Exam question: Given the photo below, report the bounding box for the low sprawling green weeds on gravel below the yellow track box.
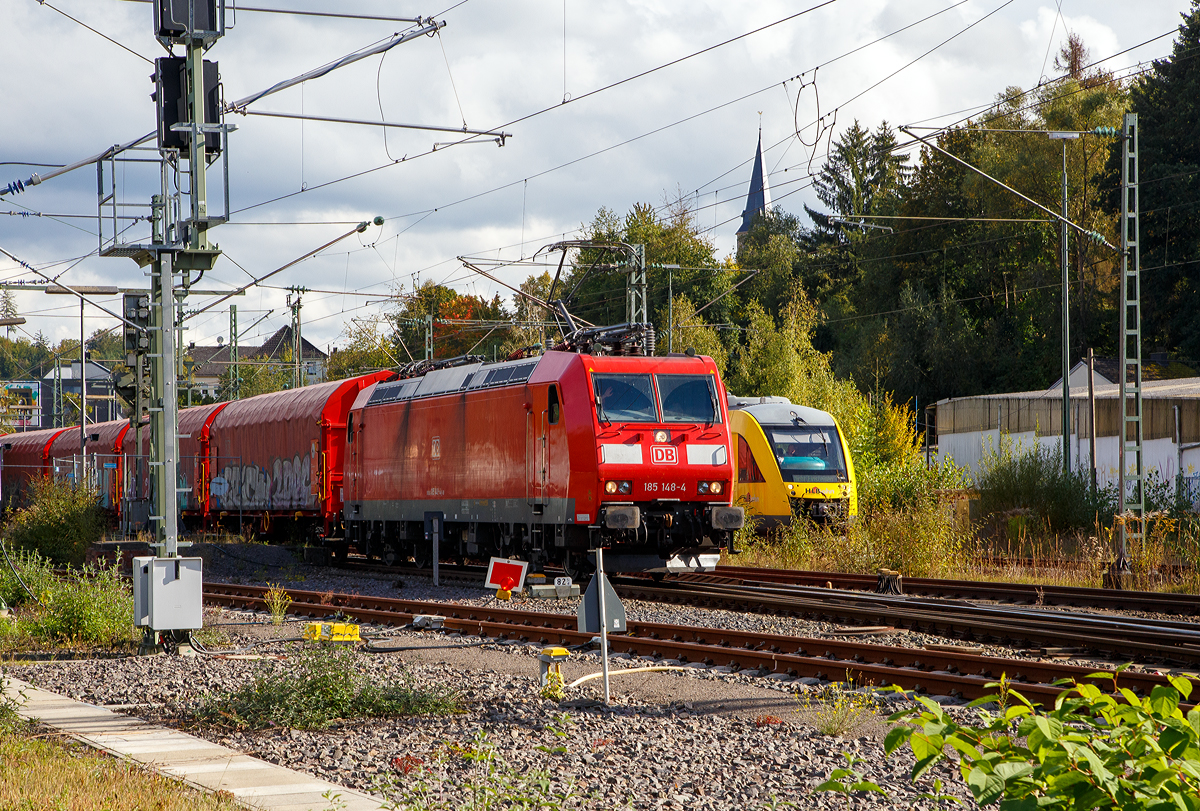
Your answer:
[193,644,458,729]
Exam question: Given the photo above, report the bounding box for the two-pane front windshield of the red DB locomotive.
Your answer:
[592,374,721,422]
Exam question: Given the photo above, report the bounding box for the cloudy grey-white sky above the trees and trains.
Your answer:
[0,0,1189,357]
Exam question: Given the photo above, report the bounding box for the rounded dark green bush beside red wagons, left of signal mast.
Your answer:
[4,477,106,565]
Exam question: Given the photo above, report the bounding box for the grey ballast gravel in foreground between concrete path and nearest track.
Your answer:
[8,612,973,810]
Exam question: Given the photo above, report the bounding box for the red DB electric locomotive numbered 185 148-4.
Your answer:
[344,352,744,575]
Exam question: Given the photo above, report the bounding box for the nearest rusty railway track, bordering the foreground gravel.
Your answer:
[204,583,1195,703]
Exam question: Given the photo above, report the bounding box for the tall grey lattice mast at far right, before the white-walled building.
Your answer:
[1114,113,1146,573]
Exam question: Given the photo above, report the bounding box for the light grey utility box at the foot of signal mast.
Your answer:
[133,558,204,631]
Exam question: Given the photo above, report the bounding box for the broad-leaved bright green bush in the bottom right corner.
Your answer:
[884,671,1200,811]
